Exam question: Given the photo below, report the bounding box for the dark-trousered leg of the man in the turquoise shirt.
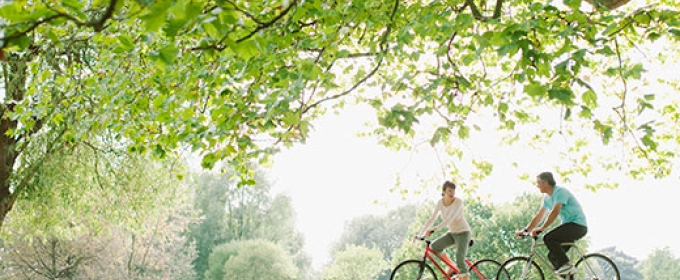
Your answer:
[543,223,588,269]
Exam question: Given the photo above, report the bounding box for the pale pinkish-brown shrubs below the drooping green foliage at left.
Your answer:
[0,209,196,280]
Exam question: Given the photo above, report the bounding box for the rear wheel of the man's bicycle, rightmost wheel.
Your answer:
[574,253,621,280]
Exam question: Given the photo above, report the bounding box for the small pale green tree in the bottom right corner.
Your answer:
[640,247,680,280]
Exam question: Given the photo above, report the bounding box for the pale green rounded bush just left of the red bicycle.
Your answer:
[323,245,387,280]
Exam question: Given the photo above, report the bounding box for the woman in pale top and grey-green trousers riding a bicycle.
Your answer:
[419,181,472,280]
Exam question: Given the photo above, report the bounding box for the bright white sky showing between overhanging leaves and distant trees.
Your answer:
[269,102,680,269]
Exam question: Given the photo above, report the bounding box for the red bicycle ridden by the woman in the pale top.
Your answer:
[390,236,501,280]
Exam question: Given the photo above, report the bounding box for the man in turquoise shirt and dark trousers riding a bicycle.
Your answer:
[516,172,588,275]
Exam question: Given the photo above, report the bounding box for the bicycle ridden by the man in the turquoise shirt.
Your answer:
[496,233,621,280]
